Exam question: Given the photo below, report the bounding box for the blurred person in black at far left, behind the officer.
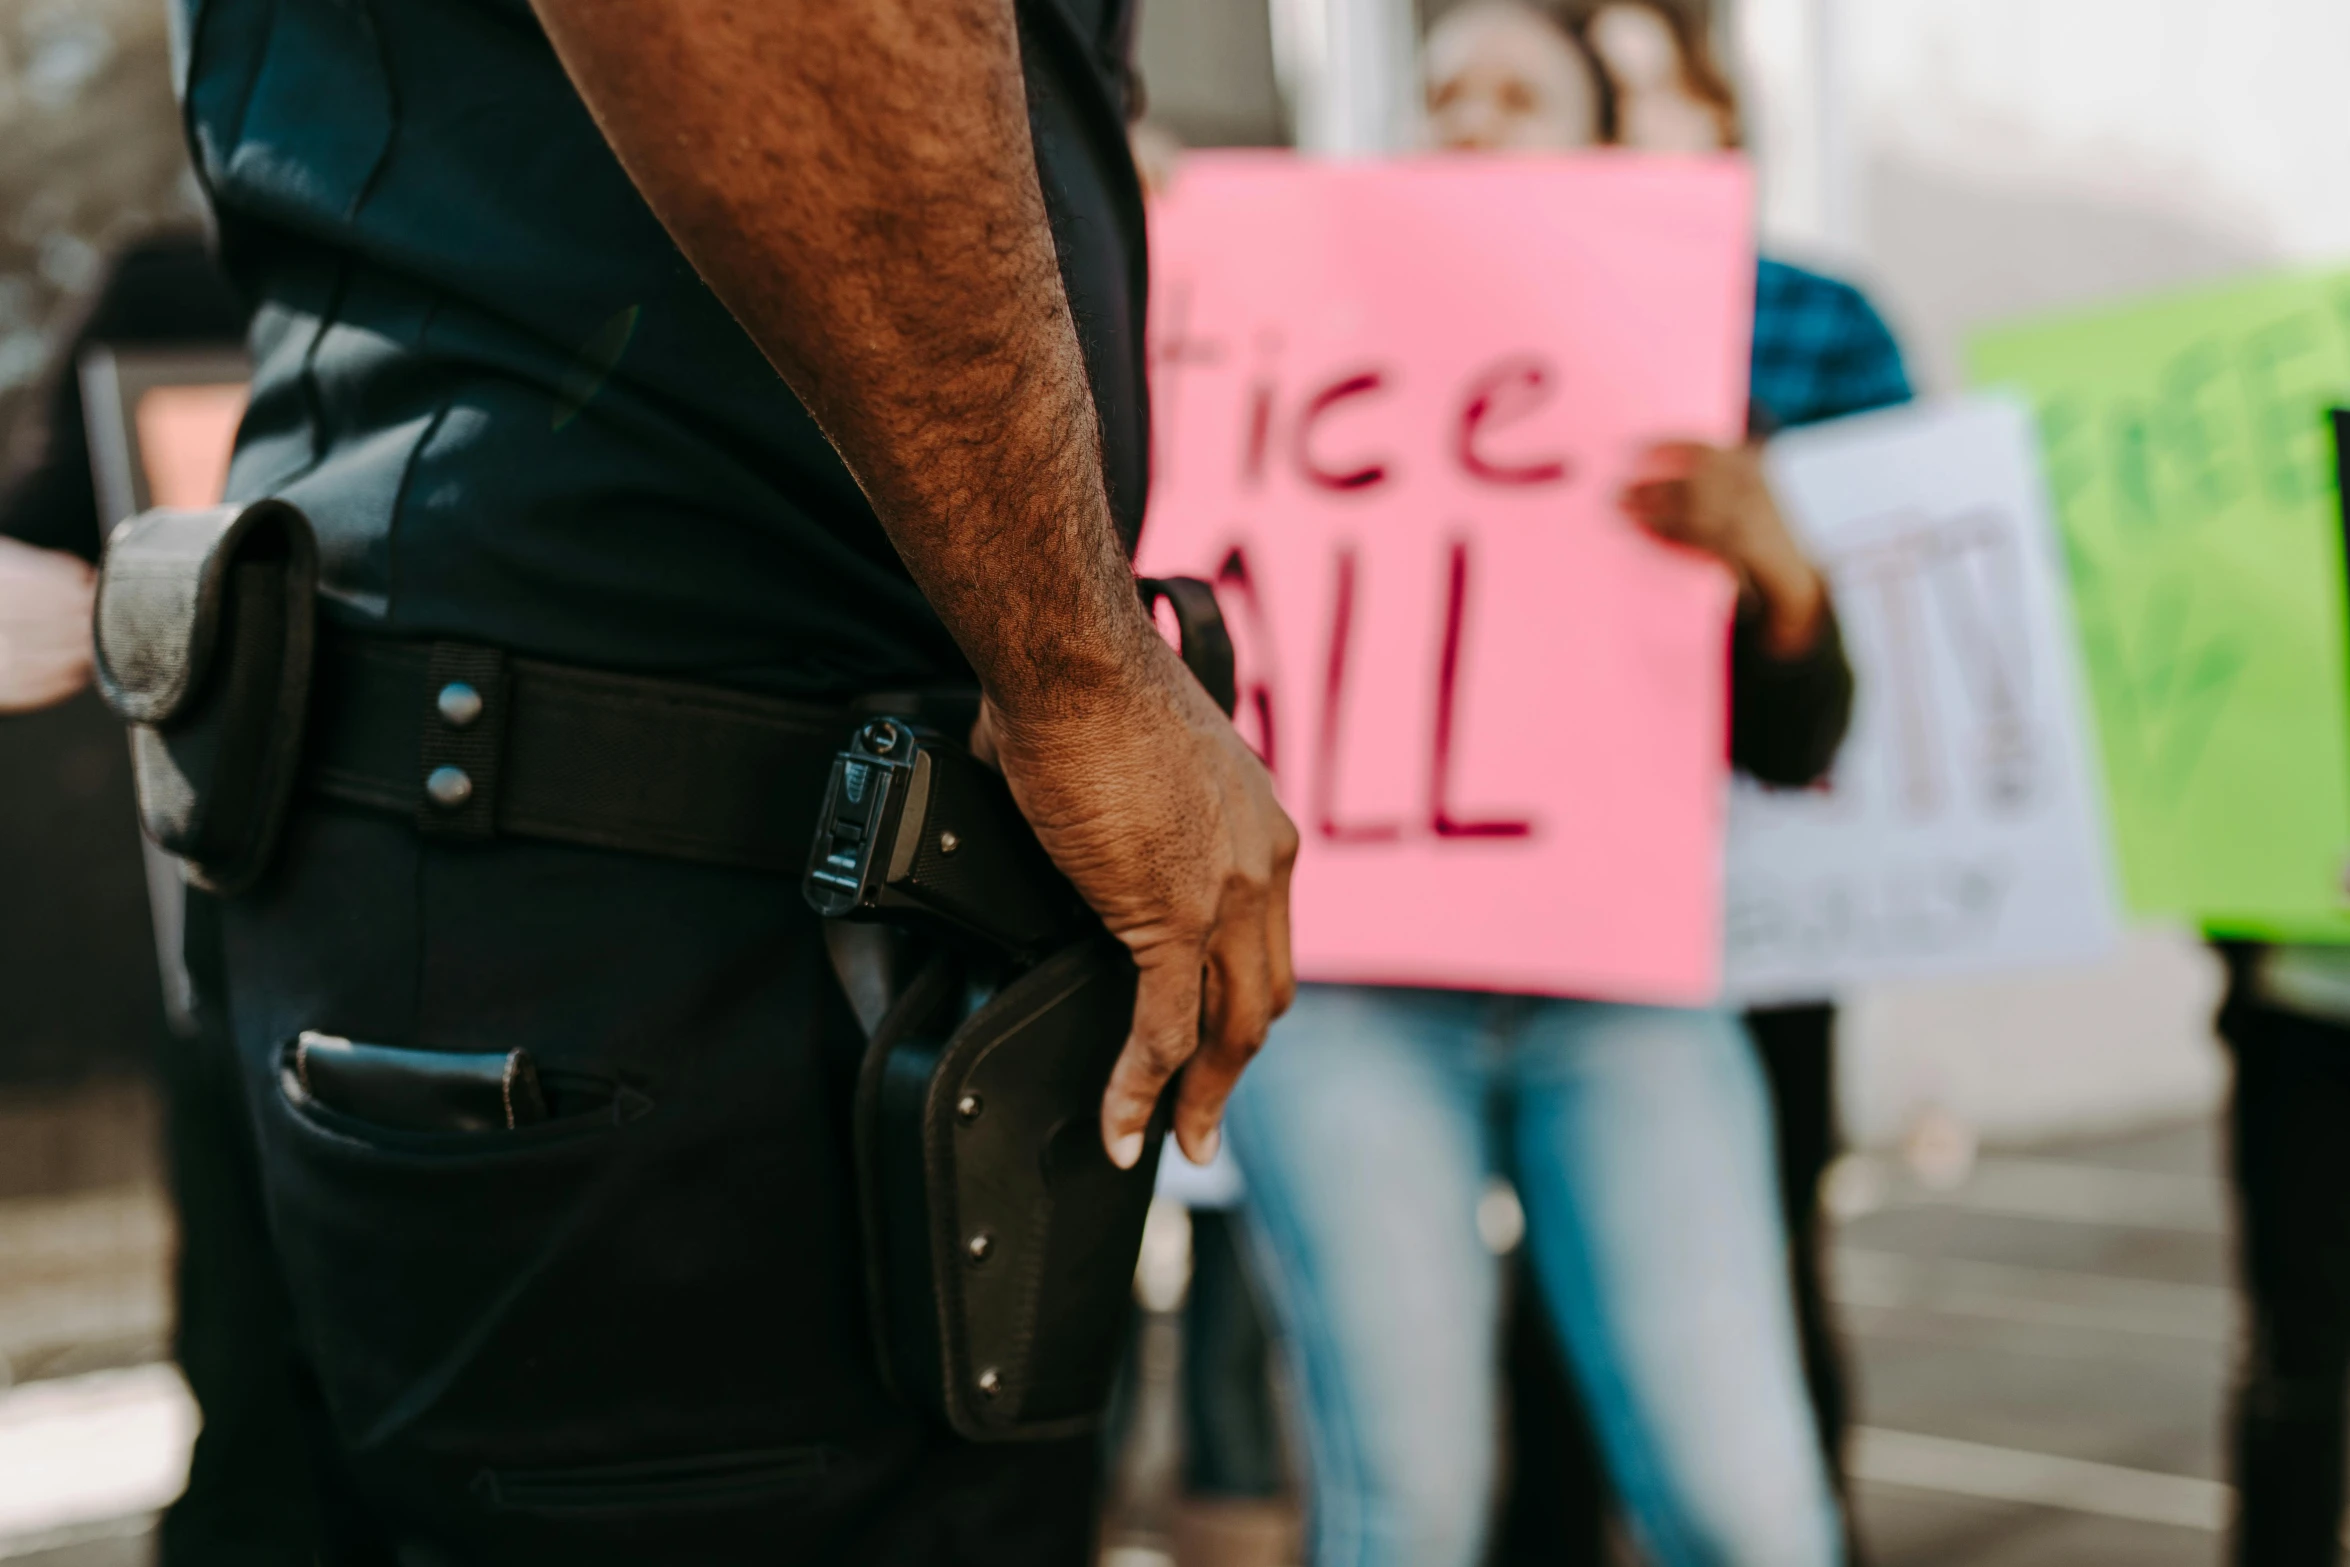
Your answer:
[0,230,320,1567]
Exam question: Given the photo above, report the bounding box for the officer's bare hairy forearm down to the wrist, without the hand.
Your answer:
[533,0,1149,714]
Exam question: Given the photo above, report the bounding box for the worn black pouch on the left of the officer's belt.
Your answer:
[96,500,317,895]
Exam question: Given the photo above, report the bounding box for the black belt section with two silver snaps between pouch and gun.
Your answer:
[303,627,855,876]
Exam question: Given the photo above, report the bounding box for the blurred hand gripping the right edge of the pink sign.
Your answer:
[1619,442,1828,658]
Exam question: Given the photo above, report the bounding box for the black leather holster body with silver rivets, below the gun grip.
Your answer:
[855,935,1173,1440]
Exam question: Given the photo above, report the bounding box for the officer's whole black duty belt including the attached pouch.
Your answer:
[96,500,1231,895]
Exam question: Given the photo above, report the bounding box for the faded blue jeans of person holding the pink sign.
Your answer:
[1229,987,1842,1567]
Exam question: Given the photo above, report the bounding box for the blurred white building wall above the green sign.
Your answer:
[1732,0,2350,388]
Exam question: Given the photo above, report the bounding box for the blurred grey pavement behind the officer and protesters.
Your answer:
[0,1121,2284,1567]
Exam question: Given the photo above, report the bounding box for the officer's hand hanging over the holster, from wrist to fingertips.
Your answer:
[980,634,1297,1170]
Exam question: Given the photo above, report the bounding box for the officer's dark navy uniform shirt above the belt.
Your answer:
[181,0,1147,695]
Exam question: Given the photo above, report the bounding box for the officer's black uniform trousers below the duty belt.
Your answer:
[223,806,1100,1567]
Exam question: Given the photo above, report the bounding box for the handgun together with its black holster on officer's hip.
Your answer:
[806,578,1234,1440]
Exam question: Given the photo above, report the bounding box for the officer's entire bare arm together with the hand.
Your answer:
[531,0,1297,1168]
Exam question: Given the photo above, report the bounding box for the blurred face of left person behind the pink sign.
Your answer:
[1426,0,1600,153]
